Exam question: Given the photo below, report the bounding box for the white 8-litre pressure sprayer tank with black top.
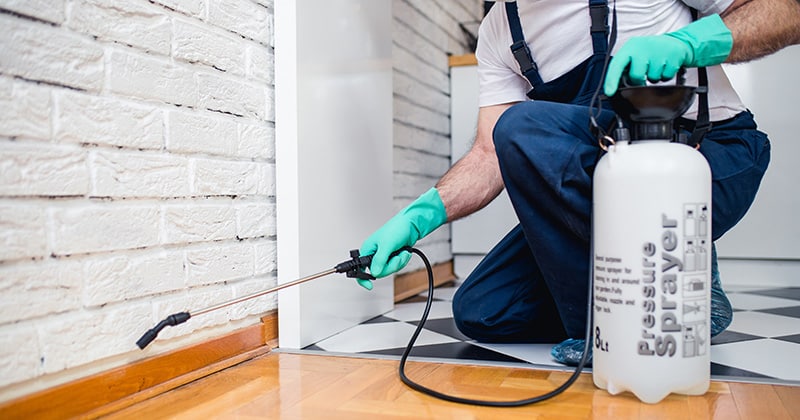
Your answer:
[592,74,711,403]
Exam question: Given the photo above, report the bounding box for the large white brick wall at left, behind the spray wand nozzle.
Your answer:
[0,0,276,401]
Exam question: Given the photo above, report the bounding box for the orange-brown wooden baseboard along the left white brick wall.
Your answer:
[0,311,278,419]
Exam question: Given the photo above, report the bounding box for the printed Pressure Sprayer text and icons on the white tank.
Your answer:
[594,203,710,357]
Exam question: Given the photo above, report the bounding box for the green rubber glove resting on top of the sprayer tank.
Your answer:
[603,15,733,96]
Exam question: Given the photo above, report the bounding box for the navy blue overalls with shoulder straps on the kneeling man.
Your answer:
[453,0,770,343]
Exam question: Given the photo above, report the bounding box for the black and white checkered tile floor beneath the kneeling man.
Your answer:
[303,287,800,386]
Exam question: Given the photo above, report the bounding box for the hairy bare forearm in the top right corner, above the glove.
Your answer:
[720,0,800,63]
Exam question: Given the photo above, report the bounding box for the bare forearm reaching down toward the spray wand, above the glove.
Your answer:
[436,104,512,222]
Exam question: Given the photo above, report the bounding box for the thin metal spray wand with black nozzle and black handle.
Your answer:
[136,249,384,350]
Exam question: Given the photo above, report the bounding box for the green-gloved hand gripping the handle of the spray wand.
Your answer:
[358,188,447,290]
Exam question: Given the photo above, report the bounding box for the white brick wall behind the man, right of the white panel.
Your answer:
[392,0,483,272]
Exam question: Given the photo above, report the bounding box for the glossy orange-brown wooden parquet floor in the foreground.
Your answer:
[104,352,800,420]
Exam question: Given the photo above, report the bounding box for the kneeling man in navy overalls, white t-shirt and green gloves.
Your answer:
[361,0,800,363]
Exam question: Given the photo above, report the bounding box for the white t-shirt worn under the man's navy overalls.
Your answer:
[475,0,745,121]
